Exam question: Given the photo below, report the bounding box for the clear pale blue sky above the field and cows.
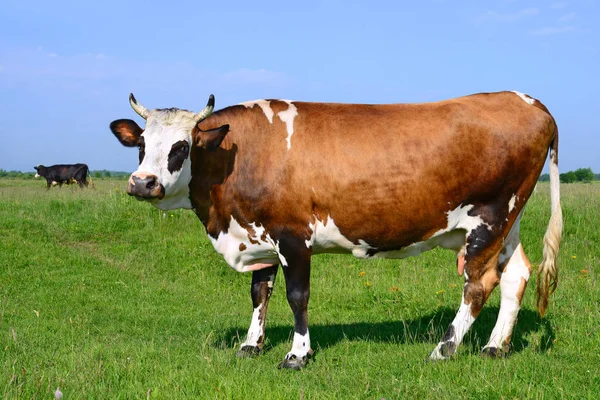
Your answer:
[0,0,600,172]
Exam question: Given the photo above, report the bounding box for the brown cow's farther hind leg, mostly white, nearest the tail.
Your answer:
[482,216,531,357]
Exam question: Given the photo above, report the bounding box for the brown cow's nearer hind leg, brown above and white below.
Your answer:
[429,224,502,360]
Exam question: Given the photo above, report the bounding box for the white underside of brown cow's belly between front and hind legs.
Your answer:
[306,217,467,258]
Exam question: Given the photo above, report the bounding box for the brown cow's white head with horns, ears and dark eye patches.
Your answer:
[110,94,227,210]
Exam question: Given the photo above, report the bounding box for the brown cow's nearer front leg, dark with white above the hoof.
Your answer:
[279,248,313,369]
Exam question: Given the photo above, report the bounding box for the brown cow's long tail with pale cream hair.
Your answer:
[536,120,563,317]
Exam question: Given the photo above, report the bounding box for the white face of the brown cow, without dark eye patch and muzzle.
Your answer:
[133,109,196,210]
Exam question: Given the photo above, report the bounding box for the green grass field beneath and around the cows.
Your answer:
[0,179,600,399]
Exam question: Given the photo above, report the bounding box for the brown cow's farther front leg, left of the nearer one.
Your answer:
[237,264,279,357]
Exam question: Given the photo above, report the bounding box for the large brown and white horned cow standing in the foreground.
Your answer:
[110,92,562,368]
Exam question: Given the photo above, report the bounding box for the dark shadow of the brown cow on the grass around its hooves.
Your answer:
[213,307,554,353]
